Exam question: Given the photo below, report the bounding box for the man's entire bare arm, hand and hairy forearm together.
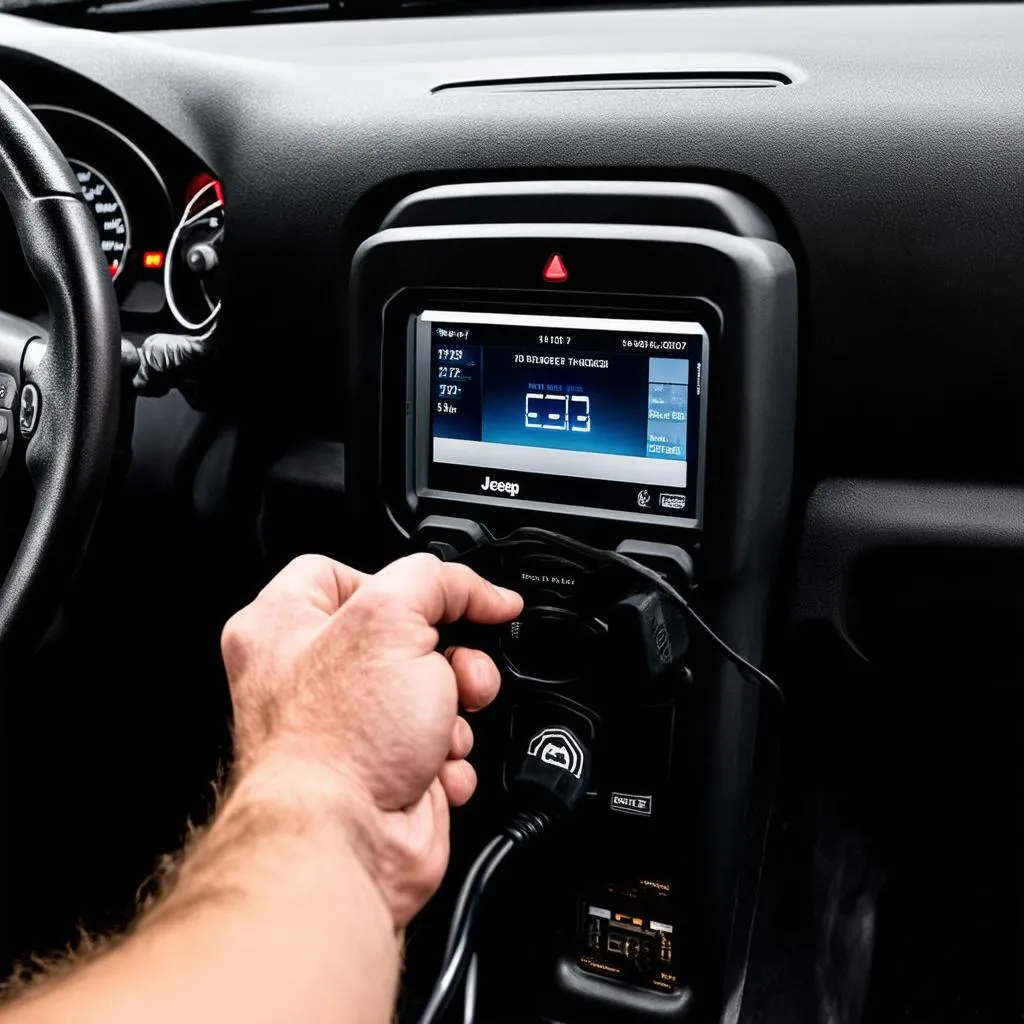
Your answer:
[0,555,522,1024]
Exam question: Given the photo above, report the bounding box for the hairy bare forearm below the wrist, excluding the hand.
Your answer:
[0,765,399,1024]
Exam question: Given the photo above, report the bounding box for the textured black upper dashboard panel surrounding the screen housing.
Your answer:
[3,4,1021,464]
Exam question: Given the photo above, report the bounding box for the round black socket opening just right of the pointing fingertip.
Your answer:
[500,606,604,685]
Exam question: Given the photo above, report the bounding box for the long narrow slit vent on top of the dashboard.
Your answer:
[430,71,793,93]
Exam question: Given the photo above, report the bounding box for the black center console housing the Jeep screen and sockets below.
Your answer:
[345,181,797,1024]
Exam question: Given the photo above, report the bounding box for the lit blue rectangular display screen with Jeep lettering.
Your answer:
[419,311,707,519]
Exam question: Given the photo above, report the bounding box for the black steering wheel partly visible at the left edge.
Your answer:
[0,83,121,655]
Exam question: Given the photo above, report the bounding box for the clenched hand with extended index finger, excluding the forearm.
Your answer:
[222,555,522,928]
